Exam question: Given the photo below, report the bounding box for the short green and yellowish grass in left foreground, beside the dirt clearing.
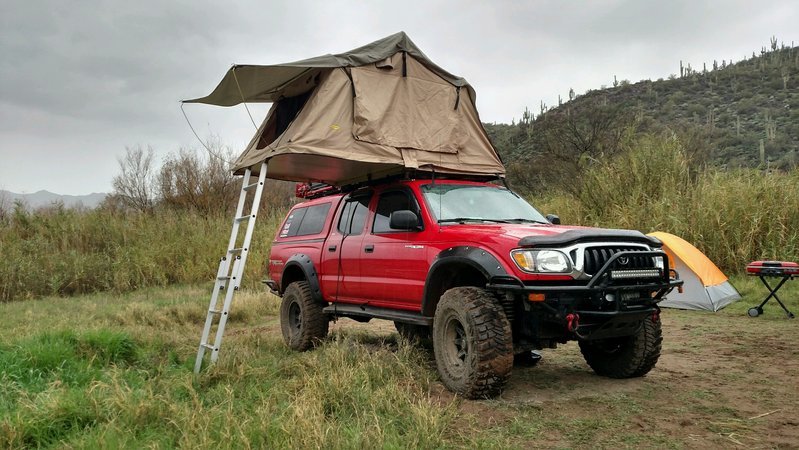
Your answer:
[0,288,454,448]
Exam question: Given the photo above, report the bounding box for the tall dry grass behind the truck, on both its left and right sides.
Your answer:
[0,131,799,301]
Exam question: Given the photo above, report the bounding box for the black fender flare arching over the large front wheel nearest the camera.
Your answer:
[422,245,508,316]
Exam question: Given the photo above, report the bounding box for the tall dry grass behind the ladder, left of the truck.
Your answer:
[0,206,284,301]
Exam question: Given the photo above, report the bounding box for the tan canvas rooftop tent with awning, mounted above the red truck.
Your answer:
[185,32,505,185]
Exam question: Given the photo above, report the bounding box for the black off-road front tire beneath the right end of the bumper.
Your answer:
[580,318,663,378]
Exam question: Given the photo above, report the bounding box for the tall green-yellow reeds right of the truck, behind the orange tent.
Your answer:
[533,135,799,273]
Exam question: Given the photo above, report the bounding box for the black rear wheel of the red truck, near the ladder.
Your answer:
[280,281,329,351]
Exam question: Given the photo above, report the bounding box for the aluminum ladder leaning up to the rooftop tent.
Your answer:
[194,162,266,373]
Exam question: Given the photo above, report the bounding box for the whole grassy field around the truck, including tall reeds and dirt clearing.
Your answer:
[0,136,799,449]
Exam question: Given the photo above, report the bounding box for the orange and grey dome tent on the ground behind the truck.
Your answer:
[649,232,741,311]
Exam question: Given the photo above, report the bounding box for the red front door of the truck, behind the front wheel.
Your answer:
[360,188,429,311]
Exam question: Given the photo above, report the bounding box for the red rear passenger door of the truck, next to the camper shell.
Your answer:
[320,192,372,303]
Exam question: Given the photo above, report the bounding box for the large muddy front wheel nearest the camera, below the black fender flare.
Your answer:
[433,287,513,399]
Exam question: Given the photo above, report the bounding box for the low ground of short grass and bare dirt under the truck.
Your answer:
[0,278,799,448]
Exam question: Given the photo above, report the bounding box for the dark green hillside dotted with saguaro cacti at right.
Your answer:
[486,39,799,169]
